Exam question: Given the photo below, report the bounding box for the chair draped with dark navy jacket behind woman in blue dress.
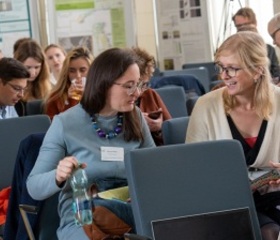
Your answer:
[4,133,59,240]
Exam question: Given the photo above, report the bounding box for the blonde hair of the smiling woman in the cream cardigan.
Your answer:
[215,31,272,120]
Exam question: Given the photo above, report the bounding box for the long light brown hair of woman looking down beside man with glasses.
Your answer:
[14,39,51,101]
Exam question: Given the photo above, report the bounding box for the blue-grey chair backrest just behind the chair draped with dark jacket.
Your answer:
[161,67,211,92]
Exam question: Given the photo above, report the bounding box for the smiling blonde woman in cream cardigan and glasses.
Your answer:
[186,31,280,240]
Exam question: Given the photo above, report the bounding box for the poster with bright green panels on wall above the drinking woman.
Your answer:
[50,0,135,56]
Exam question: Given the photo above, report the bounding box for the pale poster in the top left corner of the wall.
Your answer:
[0,0,32,57]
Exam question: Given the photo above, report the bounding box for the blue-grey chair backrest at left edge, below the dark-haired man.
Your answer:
[0,115,51,189]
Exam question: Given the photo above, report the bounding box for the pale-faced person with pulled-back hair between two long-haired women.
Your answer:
[45,44,66,86]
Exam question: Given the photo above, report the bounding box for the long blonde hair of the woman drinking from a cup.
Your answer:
[45,47,93,110]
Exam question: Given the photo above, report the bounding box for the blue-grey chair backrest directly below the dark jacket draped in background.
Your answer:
[155,86,188,118]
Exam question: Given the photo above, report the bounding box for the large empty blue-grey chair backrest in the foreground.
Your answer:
[125,140,261,240]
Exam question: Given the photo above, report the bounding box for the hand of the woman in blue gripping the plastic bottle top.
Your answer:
[55,156,79,186]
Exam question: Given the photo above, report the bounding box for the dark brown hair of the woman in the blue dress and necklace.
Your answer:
[81,48,143,141]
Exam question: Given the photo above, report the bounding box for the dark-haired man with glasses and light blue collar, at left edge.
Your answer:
[0,57,30,119]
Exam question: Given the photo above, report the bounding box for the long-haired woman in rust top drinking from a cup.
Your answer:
[44,47,93,119]
